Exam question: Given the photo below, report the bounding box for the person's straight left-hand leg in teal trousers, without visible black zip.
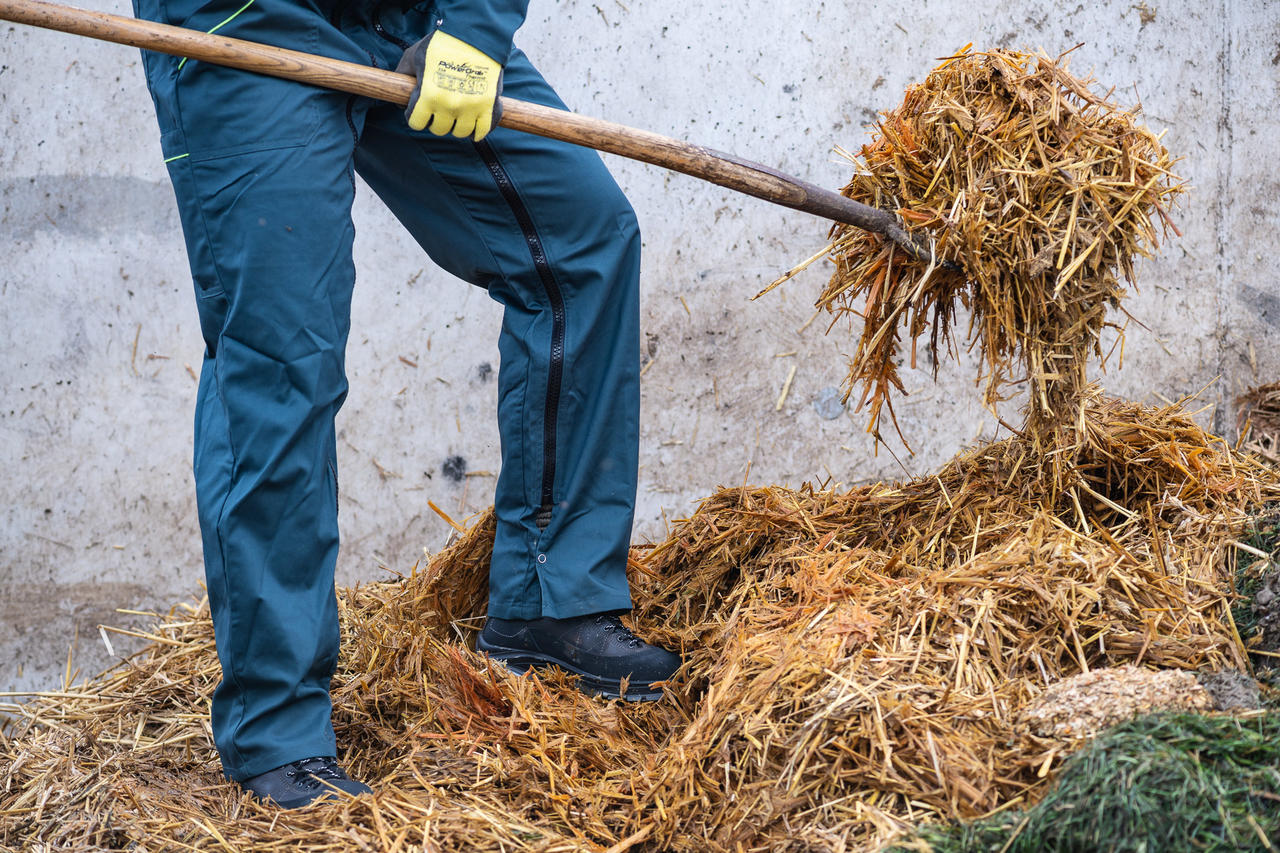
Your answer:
[137,0,373,781]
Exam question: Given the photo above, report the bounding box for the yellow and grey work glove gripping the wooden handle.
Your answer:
[396,29,502,142]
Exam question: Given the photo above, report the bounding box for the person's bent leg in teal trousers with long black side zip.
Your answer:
[356,13,640,620]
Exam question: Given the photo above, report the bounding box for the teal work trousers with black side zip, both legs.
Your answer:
[136,0,640,780]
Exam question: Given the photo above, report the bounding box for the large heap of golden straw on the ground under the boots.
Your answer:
[0,393,1280,853]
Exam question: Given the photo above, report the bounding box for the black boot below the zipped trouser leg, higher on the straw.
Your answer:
[476,613,681,702]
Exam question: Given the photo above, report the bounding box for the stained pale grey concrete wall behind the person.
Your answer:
[0,0,1280,690]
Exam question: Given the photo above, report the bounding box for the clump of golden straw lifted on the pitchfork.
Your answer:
[780,49,1181,441]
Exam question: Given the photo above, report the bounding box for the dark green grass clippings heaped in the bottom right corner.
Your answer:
[888,713,1280,853]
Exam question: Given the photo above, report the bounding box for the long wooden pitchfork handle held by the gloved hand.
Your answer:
[0,0,943,263]
